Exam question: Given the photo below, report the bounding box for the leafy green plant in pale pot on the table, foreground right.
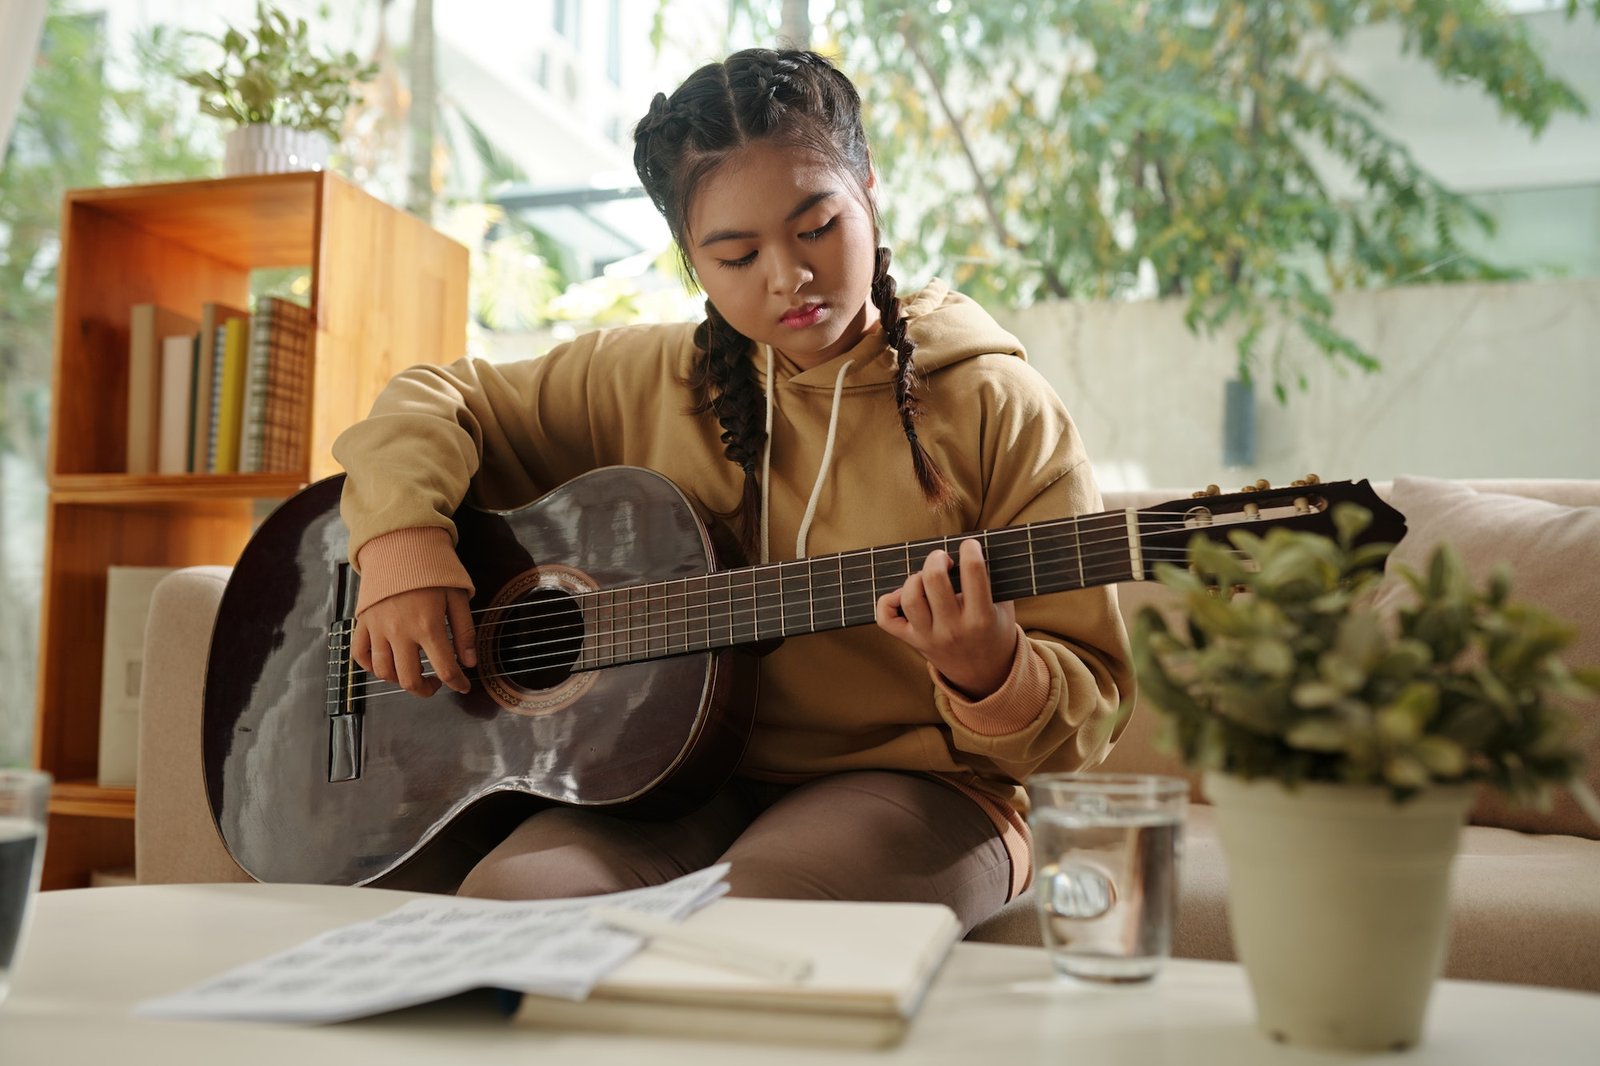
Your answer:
[1133,504,1600,1050]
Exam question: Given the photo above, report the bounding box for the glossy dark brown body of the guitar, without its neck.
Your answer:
[203,467,755,885]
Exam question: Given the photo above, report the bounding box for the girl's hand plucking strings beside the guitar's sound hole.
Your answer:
[350,587,477,696]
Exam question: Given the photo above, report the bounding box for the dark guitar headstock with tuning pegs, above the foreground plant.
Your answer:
[1139,474,1405,575]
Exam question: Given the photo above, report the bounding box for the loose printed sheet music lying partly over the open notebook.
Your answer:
[134,863,728,1021]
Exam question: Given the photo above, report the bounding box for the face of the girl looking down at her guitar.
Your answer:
[685,142,878,368]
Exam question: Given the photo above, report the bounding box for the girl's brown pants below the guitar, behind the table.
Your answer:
[459,770,1011,930]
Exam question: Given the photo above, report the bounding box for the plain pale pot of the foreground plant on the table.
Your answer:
[1205,773,1474,1052]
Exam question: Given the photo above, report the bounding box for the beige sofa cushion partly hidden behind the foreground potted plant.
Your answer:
[1374,477,1600,839]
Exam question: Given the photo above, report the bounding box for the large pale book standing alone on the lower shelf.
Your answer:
[98,567,173,789]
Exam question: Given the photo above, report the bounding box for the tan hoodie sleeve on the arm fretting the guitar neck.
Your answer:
[934,357,1133,781]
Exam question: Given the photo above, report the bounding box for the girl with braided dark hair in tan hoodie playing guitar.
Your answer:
[334,48,1133,928]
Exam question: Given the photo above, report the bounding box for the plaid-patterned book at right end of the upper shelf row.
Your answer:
[240,296,315,474]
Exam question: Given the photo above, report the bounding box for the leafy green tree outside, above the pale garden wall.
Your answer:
[731,0,1600,390]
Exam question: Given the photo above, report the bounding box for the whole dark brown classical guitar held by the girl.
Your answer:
[202,467,1405,884]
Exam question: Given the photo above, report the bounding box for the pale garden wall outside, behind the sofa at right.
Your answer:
[997,273,1600,488]
